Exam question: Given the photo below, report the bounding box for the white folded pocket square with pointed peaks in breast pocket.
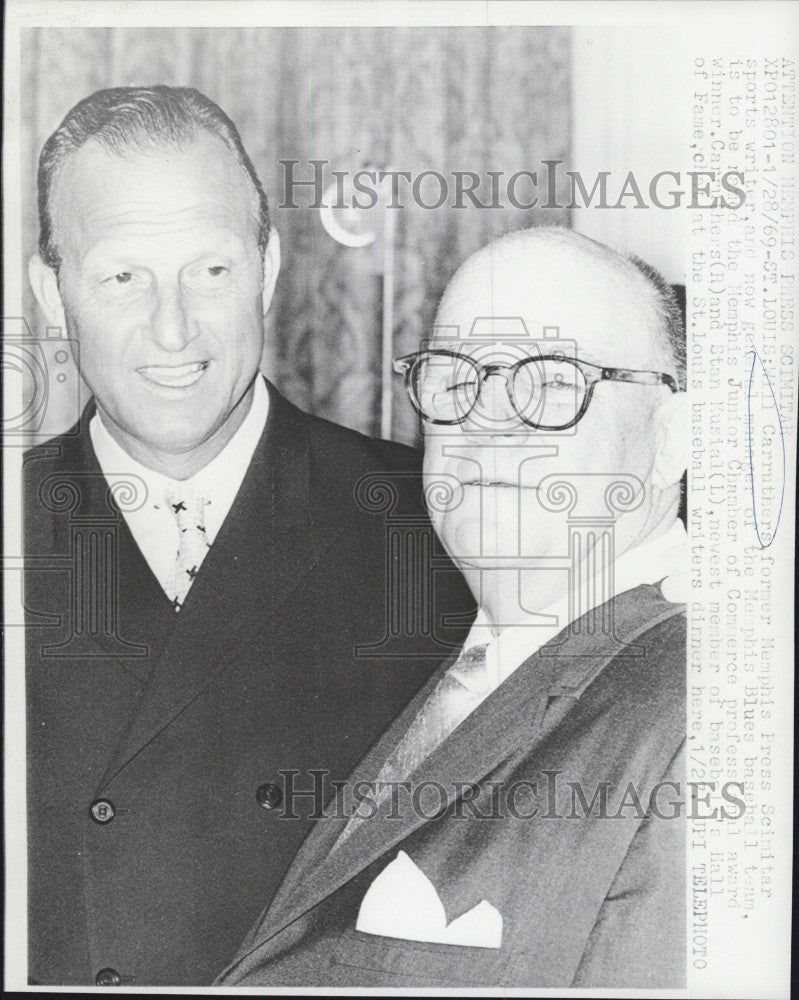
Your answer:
[355,851,502,948]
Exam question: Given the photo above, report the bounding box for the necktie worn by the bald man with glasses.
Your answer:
[334,644,495,850]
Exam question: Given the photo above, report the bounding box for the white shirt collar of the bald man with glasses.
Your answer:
[457,520,688,711]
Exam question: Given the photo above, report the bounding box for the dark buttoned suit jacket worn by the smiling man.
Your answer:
[25,378,471,985]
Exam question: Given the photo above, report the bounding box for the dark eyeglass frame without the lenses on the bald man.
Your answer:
[394,349,683,431]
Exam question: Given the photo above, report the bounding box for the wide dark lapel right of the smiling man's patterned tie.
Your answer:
[101,386,342,787]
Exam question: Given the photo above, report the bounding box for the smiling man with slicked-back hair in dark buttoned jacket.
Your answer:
[25,87,476,986]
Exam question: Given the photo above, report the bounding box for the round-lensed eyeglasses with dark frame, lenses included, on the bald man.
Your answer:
[394,350,680,431]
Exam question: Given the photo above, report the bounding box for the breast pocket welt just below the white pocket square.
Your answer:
[333,930,507,986]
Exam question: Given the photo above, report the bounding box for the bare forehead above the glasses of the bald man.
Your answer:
[431,246,662,368]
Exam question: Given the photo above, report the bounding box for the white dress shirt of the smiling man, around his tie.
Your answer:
[89,375,269,597]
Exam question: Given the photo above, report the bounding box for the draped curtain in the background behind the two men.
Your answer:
[21,27,571,442]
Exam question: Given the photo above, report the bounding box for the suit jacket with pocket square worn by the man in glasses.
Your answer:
[218,586,685,988]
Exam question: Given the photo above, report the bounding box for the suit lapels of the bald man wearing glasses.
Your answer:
[233,587,683,971]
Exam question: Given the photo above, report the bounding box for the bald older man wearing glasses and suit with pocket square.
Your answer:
[220,229,685,988]
